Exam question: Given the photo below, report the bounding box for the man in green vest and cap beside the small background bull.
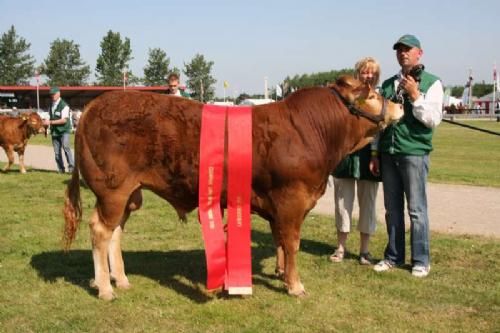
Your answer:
[45,87,74,173]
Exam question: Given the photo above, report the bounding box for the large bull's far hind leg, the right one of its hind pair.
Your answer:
[108,189,142,289]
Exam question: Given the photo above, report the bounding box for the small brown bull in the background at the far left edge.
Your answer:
[0,112,47,173]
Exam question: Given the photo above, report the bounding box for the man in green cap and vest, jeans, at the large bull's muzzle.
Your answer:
[374,35,444,277]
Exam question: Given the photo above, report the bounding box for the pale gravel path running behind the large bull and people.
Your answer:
[0,145,500,238]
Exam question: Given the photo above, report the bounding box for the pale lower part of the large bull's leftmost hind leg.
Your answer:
[90,209,115,301]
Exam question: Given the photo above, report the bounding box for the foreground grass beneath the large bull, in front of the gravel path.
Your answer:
[0,171,500,332]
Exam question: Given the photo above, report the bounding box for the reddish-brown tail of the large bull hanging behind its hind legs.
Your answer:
[63,161,82,251]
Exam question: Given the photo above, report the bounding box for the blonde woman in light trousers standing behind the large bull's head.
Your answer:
[330,57,380,265]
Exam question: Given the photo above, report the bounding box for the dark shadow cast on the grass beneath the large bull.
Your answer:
[30,231,331,303]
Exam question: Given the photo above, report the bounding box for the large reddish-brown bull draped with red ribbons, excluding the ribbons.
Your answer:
[65,77,403,299]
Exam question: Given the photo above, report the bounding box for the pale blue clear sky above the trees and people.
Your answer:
[0,0,500,96]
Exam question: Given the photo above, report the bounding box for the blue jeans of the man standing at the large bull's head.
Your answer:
[381,153,430,266]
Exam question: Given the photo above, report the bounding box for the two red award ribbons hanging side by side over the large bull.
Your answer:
[198,105,252,294]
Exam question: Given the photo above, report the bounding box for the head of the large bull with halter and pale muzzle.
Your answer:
[332,75,404,129]
